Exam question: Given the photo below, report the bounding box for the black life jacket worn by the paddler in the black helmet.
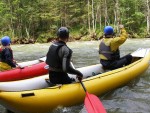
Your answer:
[46,41,66,70]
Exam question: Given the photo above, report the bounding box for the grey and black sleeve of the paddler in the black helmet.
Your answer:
[59,46,83,76]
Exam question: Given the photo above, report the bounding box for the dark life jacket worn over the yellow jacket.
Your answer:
[99,40,120,60]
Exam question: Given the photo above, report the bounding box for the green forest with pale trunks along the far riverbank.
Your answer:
[0,0,150,43]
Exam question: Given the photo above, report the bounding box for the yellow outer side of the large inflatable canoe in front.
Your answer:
[0,48,150,113]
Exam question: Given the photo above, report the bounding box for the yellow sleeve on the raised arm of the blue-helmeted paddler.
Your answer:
[111,28,128,51]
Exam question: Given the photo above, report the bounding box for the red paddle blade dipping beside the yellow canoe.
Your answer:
[84,92,107,113]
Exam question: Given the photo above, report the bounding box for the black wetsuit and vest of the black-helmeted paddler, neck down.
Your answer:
[46,41,83,84]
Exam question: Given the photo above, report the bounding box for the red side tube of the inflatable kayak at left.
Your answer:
[0,62,48,82]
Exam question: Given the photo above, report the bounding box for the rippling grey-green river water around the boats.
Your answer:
[0,39,150,113]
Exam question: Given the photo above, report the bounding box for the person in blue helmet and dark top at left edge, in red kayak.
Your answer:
[0,36,16,71]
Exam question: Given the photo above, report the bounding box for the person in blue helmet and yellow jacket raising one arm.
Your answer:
[99,25,132,70]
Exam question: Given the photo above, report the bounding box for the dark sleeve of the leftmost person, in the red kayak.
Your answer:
[4,49,16,67]
